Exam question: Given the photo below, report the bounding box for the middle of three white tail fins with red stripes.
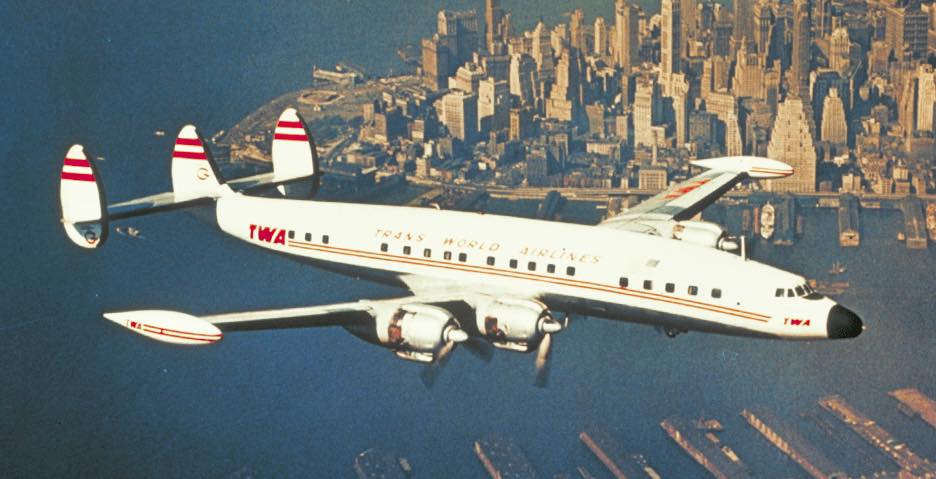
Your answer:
[172,125,222,202]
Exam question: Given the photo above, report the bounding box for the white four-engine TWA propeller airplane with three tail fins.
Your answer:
[60,108,864,385]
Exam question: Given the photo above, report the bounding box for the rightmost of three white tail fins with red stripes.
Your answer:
[273,108,320,198]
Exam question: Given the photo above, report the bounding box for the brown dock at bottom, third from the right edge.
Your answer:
[741,408,846,479]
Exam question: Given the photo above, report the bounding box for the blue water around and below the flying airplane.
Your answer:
[0,0,936,477]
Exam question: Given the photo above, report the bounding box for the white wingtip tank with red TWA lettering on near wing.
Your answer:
[104,310,223,345]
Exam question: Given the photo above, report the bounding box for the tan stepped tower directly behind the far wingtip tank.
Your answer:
[767,95,816,193]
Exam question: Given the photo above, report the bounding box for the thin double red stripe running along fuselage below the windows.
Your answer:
[289,240,770,322]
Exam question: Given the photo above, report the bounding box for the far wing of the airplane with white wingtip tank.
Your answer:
[599,156,793,232]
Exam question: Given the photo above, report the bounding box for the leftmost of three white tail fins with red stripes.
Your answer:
[59,145,107,249]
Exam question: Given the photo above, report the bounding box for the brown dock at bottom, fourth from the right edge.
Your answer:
[660,416,751,479]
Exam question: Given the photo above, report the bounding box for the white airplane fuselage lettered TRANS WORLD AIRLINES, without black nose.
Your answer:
[217,195,836,339]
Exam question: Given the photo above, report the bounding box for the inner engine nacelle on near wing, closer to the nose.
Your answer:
[476,298,562,352]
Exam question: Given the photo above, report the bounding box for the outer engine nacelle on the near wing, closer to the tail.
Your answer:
[346,303,468,362]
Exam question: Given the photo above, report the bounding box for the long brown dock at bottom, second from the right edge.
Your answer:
[819,395,936,479]
